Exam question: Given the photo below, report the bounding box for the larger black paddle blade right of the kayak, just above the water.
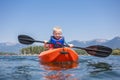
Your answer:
[85,45,112,57]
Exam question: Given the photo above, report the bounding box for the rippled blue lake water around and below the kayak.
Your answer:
[0,56,120,80]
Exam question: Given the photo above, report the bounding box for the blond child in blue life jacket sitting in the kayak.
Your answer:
[44,27,73,49]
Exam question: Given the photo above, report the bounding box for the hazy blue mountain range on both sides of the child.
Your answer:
[0,36,120,53]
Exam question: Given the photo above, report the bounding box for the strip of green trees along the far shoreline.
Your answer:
[0,46,120,55]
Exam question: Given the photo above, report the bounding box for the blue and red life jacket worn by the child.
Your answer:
[49,36,65,48]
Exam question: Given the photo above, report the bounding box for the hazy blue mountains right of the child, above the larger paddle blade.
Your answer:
[69,36,120,49]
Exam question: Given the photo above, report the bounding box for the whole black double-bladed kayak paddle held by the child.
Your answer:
[18,35,112,57]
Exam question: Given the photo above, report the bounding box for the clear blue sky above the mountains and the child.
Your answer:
[0,0,120,43]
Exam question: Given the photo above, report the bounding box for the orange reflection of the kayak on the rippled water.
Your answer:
[40,62,78,80]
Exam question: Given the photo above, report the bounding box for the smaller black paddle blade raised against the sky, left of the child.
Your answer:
[18,35,35,45]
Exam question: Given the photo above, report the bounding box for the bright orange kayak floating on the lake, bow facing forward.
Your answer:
[39,47,78,63]
